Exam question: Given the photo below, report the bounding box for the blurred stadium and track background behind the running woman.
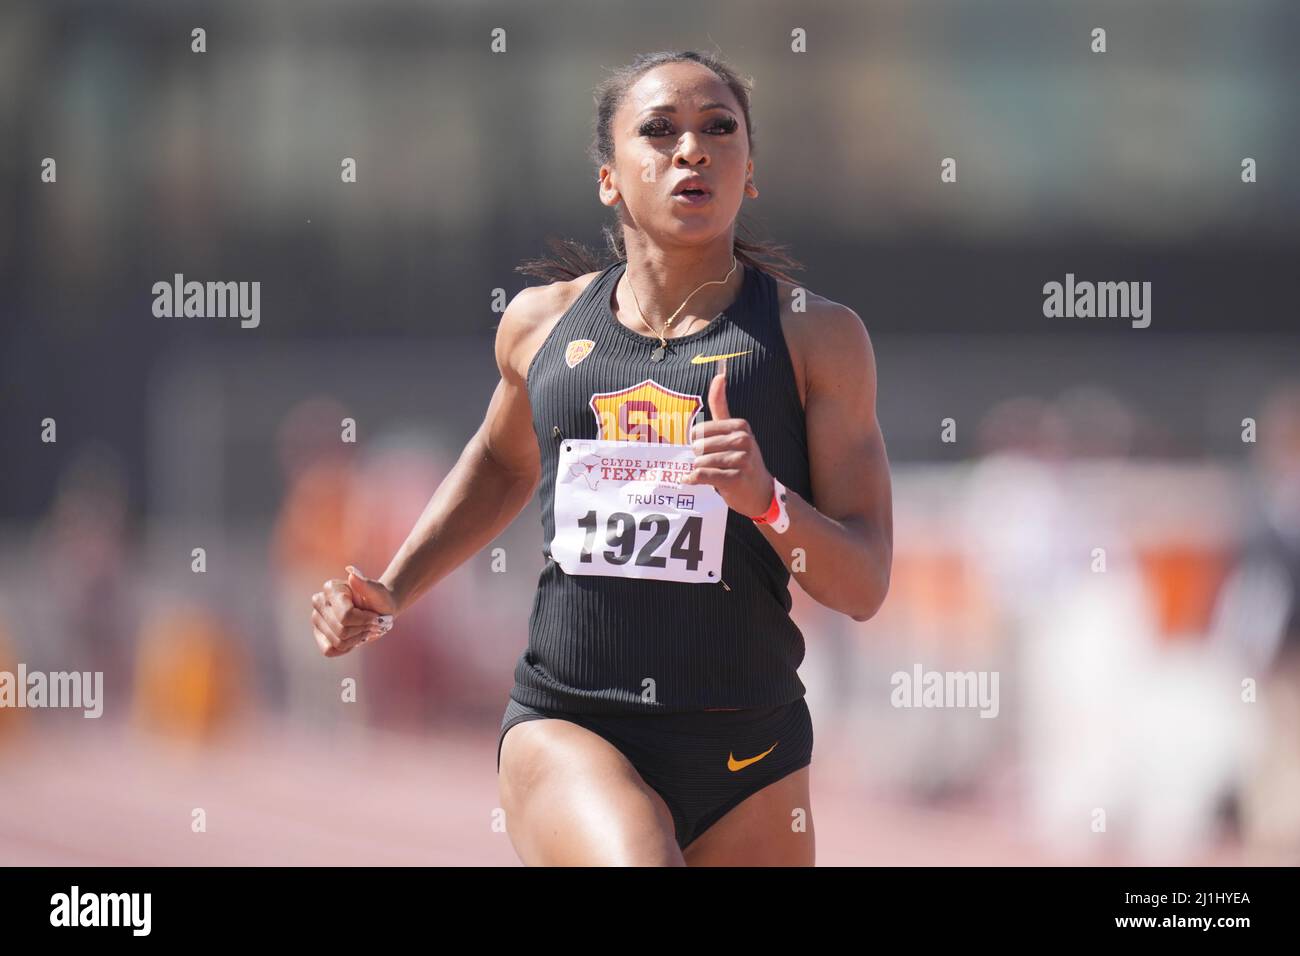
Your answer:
[0,0,1300,865]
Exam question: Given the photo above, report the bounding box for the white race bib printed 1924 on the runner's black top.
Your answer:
[551,438,727,584]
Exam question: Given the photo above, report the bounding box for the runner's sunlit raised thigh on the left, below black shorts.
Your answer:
[498,718,684,866]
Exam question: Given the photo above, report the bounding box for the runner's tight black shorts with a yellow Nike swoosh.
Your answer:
[497,697,813,849]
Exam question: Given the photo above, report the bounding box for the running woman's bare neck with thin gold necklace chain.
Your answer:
[615,230,745,338]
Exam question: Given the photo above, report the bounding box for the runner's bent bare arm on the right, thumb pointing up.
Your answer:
[684,299,893,620]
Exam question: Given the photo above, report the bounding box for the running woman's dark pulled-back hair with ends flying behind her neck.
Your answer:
[515,51,803,285]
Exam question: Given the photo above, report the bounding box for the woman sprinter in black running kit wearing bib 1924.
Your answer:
[312,52,893,865]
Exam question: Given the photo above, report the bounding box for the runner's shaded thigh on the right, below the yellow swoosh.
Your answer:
[685,766,816,866]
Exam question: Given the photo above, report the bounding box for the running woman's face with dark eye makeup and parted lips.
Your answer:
[601,62,758,245]
